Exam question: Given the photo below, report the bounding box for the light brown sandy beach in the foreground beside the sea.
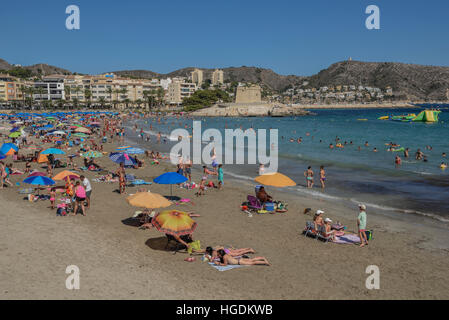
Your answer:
[0,120,449,300]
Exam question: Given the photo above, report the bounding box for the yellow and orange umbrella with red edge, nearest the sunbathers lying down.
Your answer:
[151,210,197,236]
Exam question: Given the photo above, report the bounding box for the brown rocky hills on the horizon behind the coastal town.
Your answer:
[0,59,449,100]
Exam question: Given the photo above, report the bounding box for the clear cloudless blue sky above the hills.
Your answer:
[0,0,449,75]
